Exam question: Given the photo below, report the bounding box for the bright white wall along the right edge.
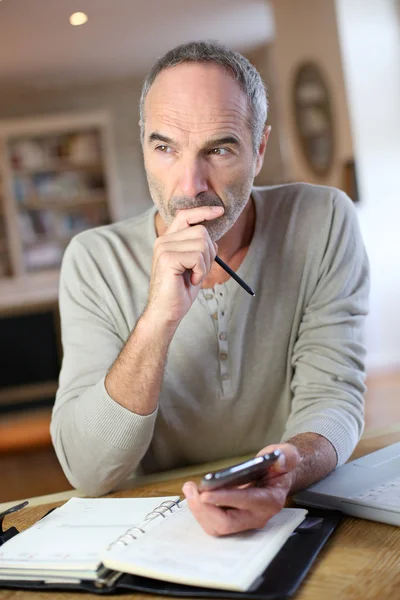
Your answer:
[337,0,400,369]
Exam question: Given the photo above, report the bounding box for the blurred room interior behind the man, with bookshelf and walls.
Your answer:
[0,0,400,502]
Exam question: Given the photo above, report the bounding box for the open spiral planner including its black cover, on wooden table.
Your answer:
[0,497,338,599]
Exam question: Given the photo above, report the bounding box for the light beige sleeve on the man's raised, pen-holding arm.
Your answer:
[51,238,156,495]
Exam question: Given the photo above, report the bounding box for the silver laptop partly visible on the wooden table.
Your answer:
[294,442,400,525]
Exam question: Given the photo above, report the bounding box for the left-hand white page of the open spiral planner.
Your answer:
[0,496,178,579]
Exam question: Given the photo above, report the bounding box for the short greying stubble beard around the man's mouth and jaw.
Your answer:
[147,173,253,242]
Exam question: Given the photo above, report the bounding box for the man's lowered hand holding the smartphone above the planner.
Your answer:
[183,444,300,536]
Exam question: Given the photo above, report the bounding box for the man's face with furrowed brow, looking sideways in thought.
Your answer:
[143,63,262,241]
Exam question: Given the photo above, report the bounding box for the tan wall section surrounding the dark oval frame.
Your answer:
[271,0,353,187]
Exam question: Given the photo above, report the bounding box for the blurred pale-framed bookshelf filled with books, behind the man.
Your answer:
[0,113,119,279]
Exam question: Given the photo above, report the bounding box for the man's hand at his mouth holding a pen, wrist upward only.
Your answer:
[145,206,224,327]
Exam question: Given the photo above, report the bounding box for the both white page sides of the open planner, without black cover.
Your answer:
[0,497,307,592]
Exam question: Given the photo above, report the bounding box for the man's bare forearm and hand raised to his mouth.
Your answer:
[105,206,224,416]
